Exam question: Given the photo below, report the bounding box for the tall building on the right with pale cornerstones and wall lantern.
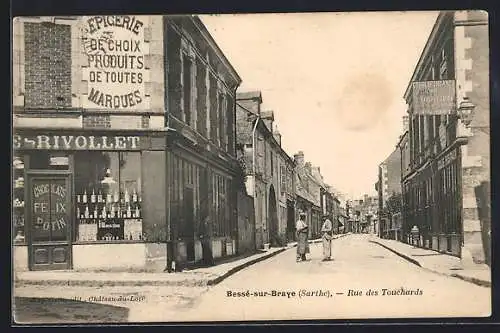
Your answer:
[402,11,490,262]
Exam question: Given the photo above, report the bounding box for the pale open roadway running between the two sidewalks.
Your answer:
[12,235,491,322]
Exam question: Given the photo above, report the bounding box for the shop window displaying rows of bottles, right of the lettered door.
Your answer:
[75,152,143,242]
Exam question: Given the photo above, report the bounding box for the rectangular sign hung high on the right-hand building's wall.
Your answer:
[412,80,455,115]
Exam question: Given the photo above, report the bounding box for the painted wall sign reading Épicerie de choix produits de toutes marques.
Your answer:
[81,15,149,109]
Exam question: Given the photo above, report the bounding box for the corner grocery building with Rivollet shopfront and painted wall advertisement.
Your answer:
[13,16,241,270]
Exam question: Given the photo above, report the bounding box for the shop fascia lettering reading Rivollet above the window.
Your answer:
[14,135,141,150]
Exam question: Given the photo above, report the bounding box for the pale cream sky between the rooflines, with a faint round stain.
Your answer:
[200,12,438,199]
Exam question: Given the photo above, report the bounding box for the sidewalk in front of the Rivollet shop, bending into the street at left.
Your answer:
[14,246,290,287]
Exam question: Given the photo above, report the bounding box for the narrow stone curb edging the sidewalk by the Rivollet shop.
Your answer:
[14,248,287,287]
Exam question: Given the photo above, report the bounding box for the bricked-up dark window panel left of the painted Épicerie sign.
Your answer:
[24,22,72,108]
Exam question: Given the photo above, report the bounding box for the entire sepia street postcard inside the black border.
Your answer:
[11,10,492,326]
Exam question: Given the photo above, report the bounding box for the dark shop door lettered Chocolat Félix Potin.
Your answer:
[28,175,72,270]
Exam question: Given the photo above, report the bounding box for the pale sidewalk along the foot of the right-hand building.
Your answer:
[370,237,491,287]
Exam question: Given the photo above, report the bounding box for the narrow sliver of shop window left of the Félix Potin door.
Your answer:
[12,156,25,244]
